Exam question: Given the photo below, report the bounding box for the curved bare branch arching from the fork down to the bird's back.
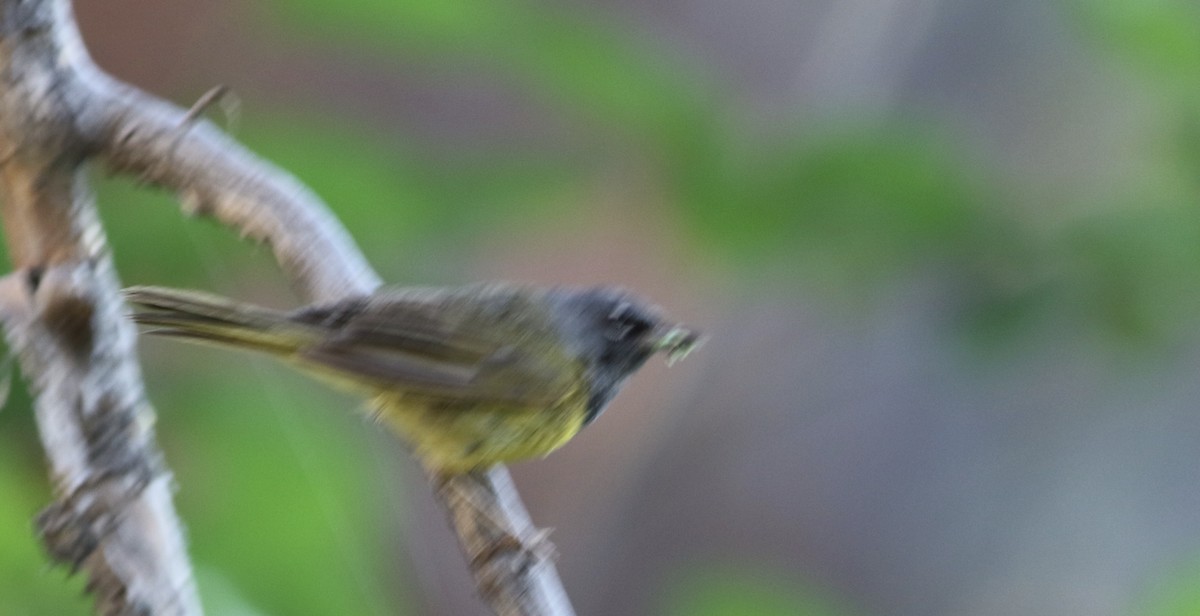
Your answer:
[87,79,379,300]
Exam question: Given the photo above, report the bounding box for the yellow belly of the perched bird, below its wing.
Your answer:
[372,390,587,473]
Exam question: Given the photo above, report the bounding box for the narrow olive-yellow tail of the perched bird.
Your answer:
[125,287,318,355]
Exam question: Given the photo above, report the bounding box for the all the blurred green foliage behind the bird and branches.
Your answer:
[0,0,1200,616]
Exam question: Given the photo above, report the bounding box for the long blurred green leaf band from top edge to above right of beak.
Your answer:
[258,0,976,276]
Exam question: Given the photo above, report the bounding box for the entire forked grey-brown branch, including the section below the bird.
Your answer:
[0,0,572,615]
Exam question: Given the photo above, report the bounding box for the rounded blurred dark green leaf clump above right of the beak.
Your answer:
[677,123,982,274]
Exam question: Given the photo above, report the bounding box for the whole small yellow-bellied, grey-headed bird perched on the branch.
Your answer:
[125,283,700,473]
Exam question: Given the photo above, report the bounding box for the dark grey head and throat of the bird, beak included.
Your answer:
[551,287,701,424]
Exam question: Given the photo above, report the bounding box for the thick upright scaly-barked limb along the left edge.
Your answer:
[0,0,200,615]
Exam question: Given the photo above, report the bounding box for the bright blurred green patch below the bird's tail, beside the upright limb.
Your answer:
[148,360,402,616]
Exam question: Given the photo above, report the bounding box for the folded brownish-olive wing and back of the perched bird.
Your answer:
[285,289,582,407]
